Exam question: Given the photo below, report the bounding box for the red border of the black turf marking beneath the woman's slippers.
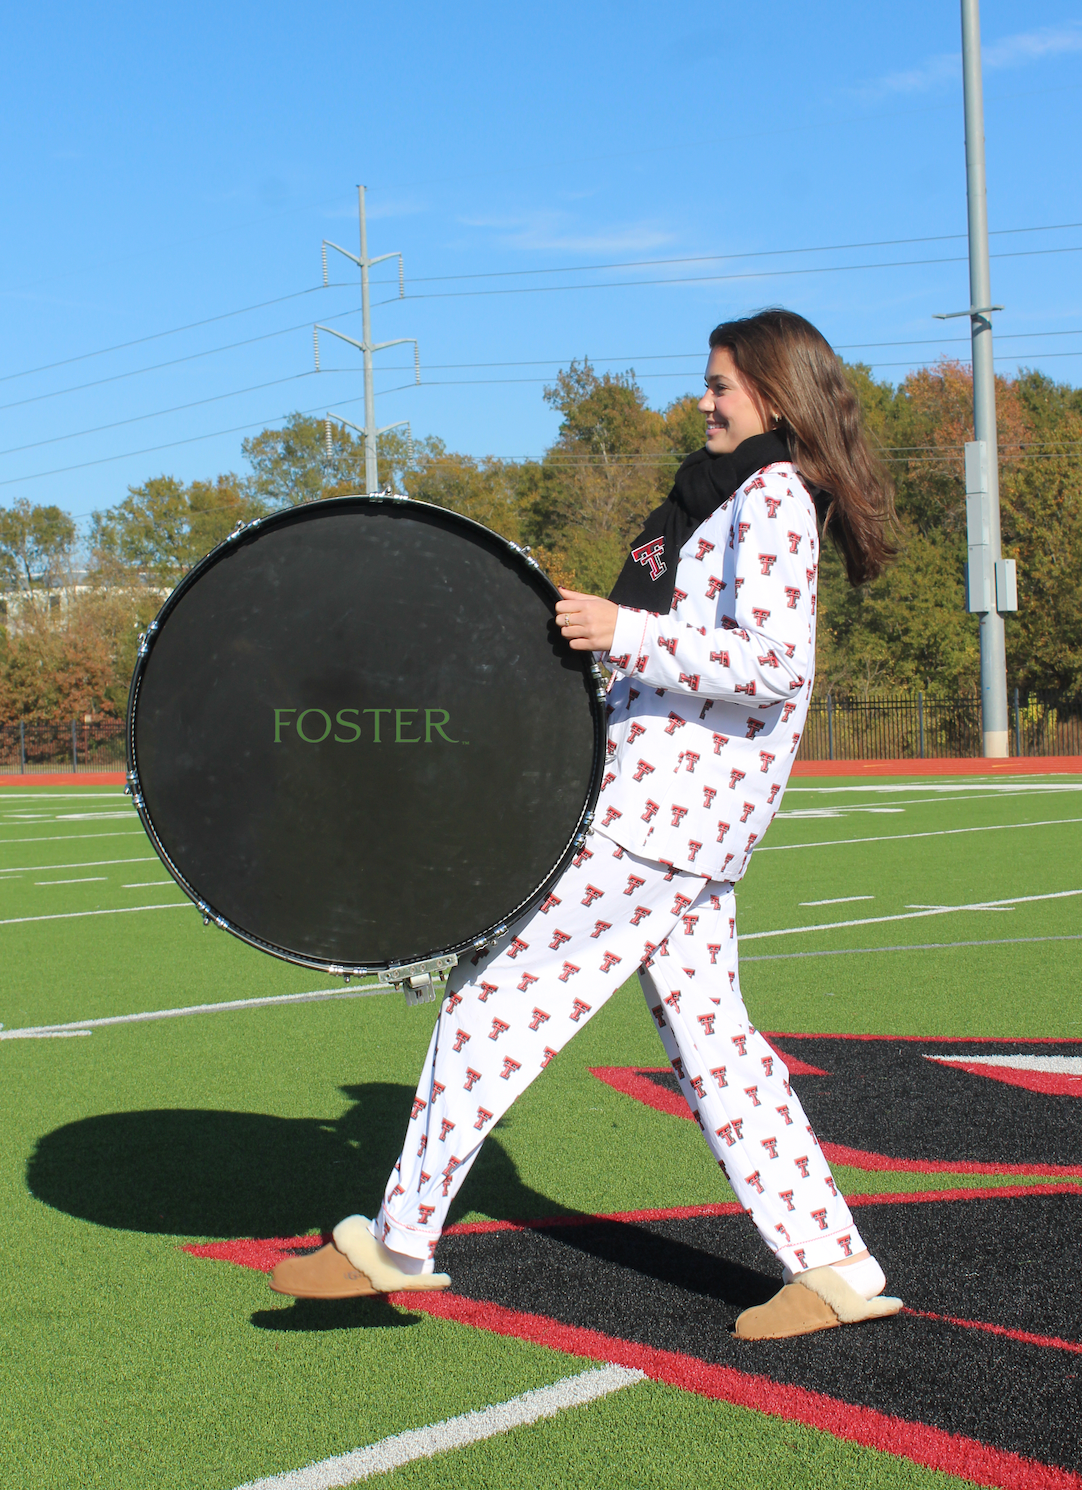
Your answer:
[183,1185,1082,1490]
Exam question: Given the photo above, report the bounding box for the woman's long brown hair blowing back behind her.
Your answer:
[709,307,897,584]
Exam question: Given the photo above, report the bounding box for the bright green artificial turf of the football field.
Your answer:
[0,778,1082,1490]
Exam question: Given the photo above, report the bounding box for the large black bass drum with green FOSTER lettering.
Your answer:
[128,496,605,974]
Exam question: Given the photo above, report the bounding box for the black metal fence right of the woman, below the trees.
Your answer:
[797,688,1082,760]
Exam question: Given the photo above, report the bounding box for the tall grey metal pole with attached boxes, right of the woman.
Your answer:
[936,0,1018,757]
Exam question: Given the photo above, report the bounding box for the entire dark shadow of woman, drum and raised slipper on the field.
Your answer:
[27,1082,776,1332]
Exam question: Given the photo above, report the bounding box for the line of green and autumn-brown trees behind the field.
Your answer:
[0,351,1082,721]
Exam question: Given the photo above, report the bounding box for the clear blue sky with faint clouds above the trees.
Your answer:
[0,0,1082,519]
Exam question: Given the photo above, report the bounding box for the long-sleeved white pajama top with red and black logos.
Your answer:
[595,460,818,882]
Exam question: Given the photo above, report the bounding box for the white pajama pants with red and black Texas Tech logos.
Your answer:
[379,831,864,1272]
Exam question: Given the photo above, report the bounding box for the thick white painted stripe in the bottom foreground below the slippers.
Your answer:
[237,1366,645,1490]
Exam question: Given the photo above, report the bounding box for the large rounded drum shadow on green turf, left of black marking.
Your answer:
[27,1082,575,1241]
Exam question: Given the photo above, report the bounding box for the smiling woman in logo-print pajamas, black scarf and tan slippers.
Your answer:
[271,310,902,1340]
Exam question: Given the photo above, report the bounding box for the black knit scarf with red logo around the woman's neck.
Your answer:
[610,431,790,615]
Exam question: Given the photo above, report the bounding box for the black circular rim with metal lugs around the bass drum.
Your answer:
[124,492,608,982]
